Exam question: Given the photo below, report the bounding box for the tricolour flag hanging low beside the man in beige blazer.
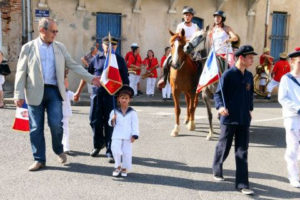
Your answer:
[13,102,29,131]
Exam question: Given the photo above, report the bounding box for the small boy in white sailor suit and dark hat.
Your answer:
[108,85,139,177]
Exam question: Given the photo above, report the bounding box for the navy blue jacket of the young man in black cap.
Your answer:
[214,66,253,126]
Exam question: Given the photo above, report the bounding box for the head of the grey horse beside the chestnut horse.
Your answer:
[183,26,209,54]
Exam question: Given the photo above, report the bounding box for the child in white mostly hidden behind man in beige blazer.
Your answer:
[62,75,74,154]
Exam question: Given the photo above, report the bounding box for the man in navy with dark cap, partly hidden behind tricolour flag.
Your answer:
[74,36,129,158]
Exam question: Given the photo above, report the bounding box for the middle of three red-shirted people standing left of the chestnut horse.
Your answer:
[143,49,159,96]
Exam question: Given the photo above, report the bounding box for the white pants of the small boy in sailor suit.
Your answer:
[111,139,132,170]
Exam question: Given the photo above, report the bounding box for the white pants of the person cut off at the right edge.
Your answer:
[284,118,300,181]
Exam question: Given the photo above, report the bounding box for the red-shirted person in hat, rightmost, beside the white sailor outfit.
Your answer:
[266,52,291,99]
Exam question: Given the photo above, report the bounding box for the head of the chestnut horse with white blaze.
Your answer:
[169,29,186,69]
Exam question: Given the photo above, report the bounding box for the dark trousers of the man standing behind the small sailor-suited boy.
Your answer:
[90,91,115,153]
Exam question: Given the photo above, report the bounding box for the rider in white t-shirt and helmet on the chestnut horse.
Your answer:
[157,7,200,88]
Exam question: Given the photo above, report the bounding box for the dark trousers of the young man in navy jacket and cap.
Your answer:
[213,124,249,189]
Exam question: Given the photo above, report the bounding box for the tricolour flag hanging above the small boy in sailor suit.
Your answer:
[100,43,123,95]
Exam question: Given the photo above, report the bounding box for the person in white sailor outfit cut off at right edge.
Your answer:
[278,48,300,188]
